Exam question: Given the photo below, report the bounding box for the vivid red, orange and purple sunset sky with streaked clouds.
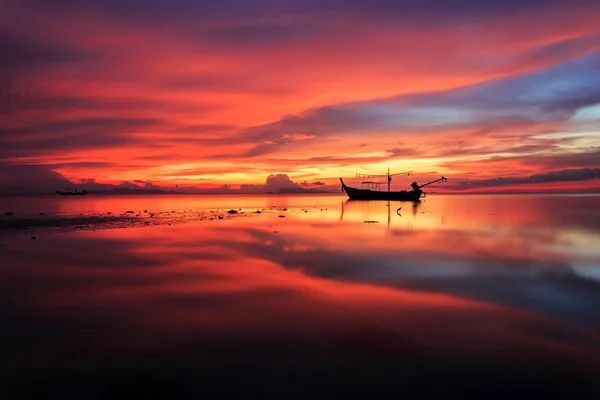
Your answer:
[0,0,600,192]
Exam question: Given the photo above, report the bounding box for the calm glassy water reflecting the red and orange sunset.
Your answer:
[0,195,600,399]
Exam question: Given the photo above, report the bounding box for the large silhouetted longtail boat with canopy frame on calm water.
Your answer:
[340,169,447,201]
